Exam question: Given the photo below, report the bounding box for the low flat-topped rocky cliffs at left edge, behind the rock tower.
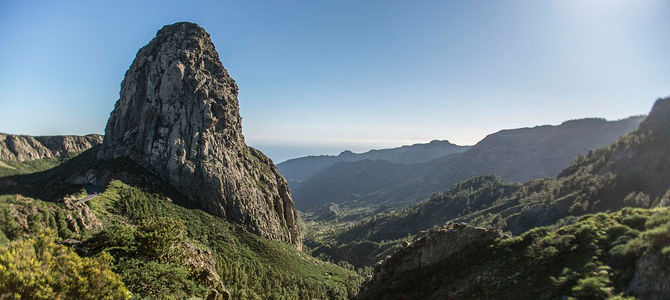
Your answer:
[0,133,103,161]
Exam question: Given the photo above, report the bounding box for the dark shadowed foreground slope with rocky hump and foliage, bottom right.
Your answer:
[358,208,670,299]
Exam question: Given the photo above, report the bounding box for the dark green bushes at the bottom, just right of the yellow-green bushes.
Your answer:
[83,219,214,299]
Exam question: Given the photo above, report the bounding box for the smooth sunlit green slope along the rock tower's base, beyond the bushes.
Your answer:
[89,181,360,299]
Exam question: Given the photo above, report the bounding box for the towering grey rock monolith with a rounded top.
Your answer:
[98,22,301,248]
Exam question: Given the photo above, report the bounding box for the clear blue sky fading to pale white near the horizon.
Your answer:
[0,0,670,162]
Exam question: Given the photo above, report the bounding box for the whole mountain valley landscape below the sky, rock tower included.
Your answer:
[0,17,670,300]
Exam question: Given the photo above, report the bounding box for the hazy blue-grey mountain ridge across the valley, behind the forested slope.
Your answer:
[292,117,643,210]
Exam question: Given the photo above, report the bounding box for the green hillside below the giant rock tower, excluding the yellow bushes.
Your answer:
[0,149,361,299]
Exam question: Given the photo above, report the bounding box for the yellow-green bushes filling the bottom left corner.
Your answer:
[0,231,130,299]
